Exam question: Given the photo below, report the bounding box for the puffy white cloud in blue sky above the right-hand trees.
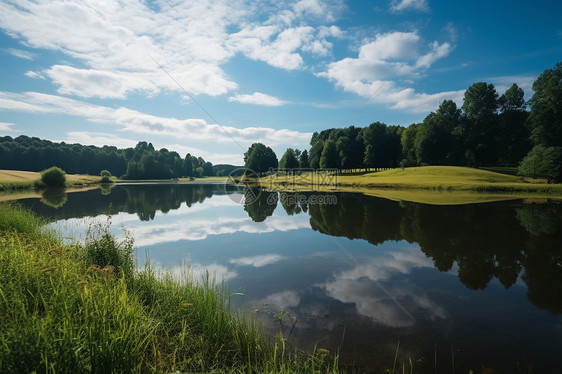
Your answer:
[317,32,464,113]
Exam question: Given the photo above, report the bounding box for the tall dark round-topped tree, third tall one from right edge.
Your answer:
[462,82,498,166]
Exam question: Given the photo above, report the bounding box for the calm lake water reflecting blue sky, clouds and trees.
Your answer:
[13,185,562,373]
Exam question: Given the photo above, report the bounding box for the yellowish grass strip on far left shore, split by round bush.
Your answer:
[0,170,100,191]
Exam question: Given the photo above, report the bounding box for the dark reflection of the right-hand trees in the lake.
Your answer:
[309,194,562,313]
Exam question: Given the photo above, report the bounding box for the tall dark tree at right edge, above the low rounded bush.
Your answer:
[529,62,562,147]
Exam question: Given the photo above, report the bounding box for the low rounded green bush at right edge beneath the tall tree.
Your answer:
[519,145,562,183]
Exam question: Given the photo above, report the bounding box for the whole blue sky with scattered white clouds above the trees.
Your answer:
[0,0,562,165]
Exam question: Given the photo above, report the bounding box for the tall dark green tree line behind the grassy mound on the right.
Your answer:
[244,62,562,182]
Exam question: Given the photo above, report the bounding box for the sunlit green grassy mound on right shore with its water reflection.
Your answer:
[260,166,562,204]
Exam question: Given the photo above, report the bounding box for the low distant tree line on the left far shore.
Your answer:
[0,135,236,179]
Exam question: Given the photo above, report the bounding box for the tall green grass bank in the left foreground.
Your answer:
[0,204,337,373]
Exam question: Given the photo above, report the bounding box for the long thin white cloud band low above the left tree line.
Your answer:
[0,92,312,148]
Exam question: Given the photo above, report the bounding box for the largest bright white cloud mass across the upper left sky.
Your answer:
[0,0,343,99]
